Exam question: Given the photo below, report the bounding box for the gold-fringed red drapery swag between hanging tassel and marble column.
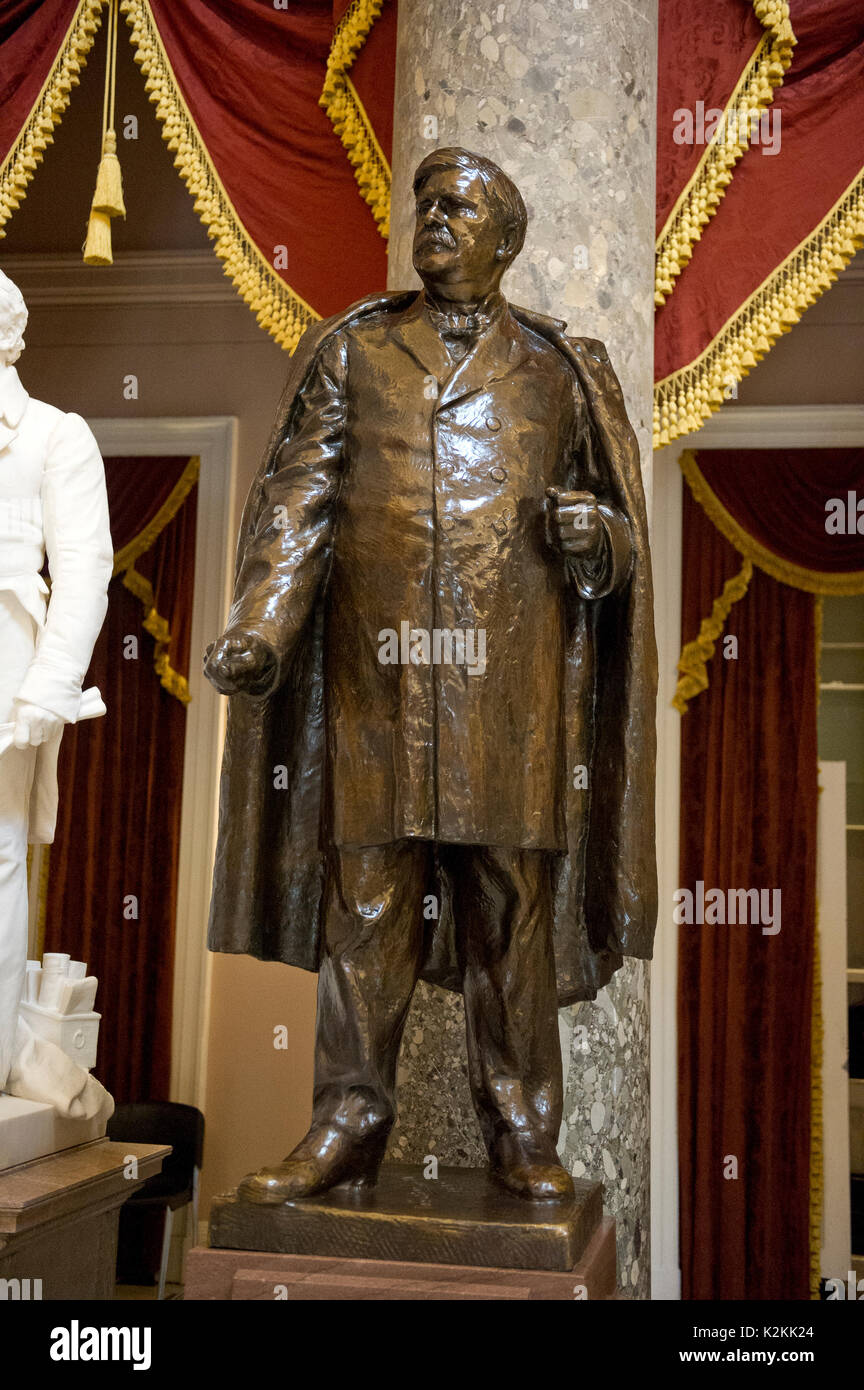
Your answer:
[121,0,392,348]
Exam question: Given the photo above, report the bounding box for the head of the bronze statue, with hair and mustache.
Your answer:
[414,149,528,295]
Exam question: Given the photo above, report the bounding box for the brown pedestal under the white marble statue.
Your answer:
[0,1140,171,1300]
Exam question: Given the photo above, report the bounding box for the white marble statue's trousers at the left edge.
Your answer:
[0,592,36,1090]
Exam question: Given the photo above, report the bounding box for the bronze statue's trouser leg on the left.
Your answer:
[313,841,432,1136]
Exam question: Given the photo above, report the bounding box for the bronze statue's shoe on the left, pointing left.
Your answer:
[238,1125,390,1205]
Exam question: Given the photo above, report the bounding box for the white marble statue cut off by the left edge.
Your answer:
[0,271,114,1104]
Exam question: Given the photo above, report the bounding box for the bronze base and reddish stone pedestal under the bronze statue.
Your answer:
[201,1163,615,1301]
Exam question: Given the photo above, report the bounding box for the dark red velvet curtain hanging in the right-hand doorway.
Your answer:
[678,489,817,1298]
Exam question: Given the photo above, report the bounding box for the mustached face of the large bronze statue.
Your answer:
[414,170,504,292]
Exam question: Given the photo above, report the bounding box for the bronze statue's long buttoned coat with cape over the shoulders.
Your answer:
[210,293,656,1002]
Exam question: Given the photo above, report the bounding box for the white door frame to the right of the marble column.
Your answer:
[651,404,864,1298]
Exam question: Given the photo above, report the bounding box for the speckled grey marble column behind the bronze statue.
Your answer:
[389,0,657,1298]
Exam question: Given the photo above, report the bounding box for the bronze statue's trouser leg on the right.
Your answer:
[442,847,563,1163]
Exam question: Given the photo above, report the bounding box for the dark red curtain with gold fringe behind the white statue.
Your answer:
[44,457,197,1101]
